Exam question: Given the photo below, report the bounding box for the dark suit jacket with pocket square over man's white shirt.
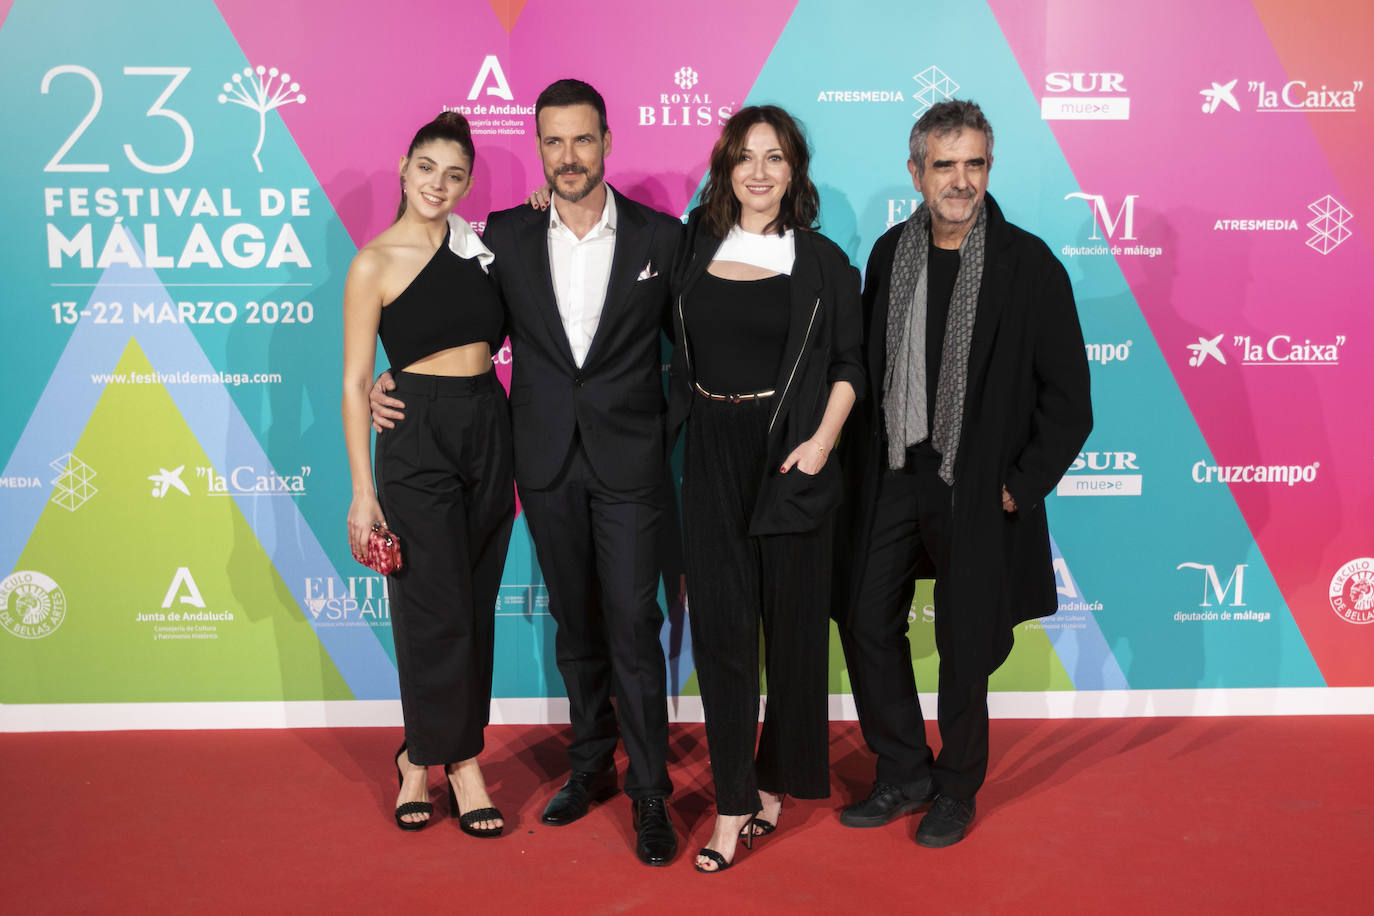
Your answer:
[482,185,682,489]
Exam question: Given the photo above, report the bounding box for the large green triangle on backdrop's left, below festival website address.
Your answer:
[0,338,353,703]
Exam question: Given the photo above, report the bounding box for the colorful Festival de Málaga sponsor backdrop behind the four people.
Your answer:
[0,0,1374,728]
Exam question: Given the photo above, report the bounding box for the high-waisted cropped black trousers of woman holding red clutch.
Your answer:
[376,372,515,766]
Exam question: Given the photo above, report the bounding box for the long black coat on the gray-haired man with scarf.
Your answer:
[835,195,1092,683]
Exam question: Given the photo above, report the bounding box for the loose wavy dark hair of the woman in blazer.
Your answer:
[701,104,820,239]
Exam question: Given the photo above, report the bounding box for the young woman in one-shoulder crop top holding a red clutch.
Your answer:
[342,113,515,836]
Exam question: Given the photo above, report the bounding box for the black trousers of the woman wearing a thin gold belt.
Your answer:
[683,398,833,816]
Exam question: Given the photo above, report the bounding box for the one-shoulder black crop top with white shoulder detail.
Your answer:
[376,227,504,369]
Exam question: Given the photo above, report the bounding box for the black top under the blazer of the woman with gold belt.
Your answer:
[684,271,791,394]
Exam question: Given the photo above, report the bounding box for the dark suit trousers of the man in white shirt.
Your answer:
[521,439,672,799]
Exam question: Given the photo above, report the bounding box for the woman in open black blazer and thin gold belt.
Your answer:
[669,106,864,872]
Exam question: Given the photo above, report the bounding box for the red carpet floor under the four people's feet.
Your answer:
[0,717,1374,916]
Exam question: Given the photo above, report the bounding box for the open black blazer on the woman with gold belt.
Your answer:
[668,207,864,536]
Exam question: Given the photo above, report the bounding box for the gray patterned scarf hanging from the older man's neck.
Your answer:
[882,203,988,485]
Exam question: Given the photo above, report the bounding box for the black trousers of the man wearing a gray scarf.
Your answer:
[841,464,988,799]
